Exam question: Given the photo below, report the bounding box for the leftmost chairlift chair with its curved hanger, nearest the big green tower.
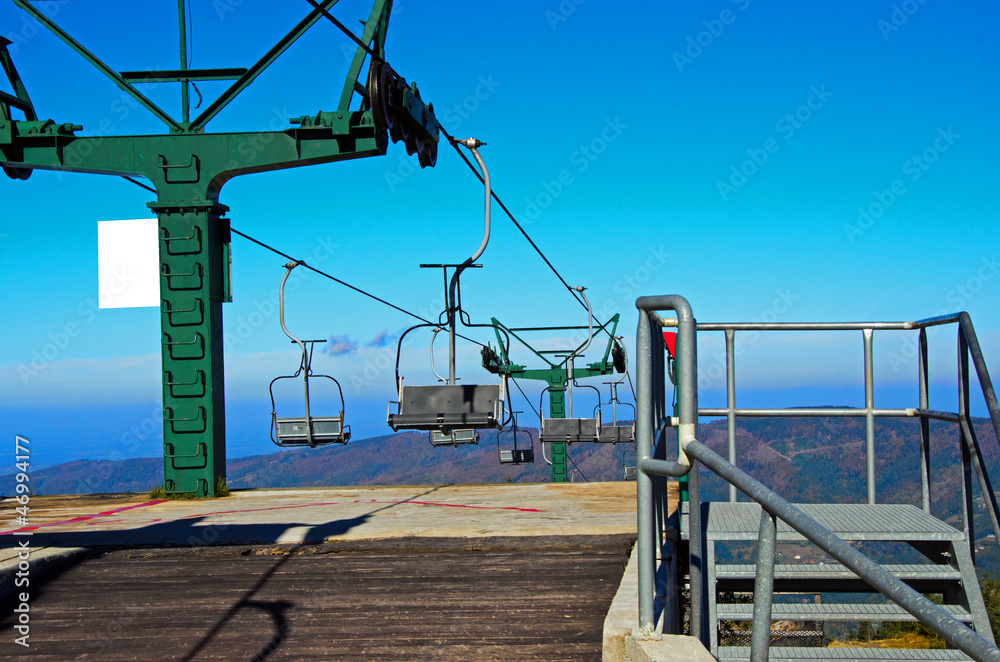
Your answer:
[268,262,351,448]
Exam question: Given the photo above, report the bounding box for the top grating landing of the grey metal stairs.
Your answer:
[681,502,965,542]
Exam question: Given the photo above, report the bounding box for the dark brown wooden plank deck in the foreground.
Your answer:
[0,535,633,662]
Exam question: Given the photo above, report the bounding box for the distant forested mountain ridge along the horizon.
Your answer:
[0,417,1000,512]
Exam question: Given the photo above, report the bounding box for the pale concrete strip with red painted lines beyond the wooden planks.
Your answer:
[0,482,636,558]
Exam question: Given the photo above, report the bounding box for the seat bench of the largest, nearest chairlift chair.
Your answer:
[387,384,504,436]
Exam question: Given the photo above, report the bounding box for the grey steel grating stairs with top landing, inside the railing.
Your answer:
[681,502,993,661]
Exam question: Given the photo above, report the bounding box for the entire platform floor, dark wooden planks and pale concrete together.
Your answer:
[0,482,701,660]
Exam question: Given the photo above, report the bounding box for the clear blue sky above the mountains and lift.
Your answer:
[0,0,1000,462]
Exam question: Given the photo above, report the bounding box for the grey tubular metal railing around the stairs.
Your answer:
[636,295,1000,660]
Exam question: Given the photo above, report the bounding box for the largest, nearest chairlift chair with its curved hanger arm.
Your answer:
[386,138,506,446]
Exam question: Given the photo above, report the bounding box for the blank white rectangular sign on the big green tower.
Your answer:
[97,218,160,308]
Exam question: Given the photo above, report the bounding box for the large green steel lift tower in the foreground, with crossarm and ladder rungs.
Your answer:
[0,0,439,496]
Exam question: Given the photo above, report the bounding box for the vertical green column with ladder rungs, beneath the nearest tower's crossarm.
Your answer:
[156,203,230,496]
